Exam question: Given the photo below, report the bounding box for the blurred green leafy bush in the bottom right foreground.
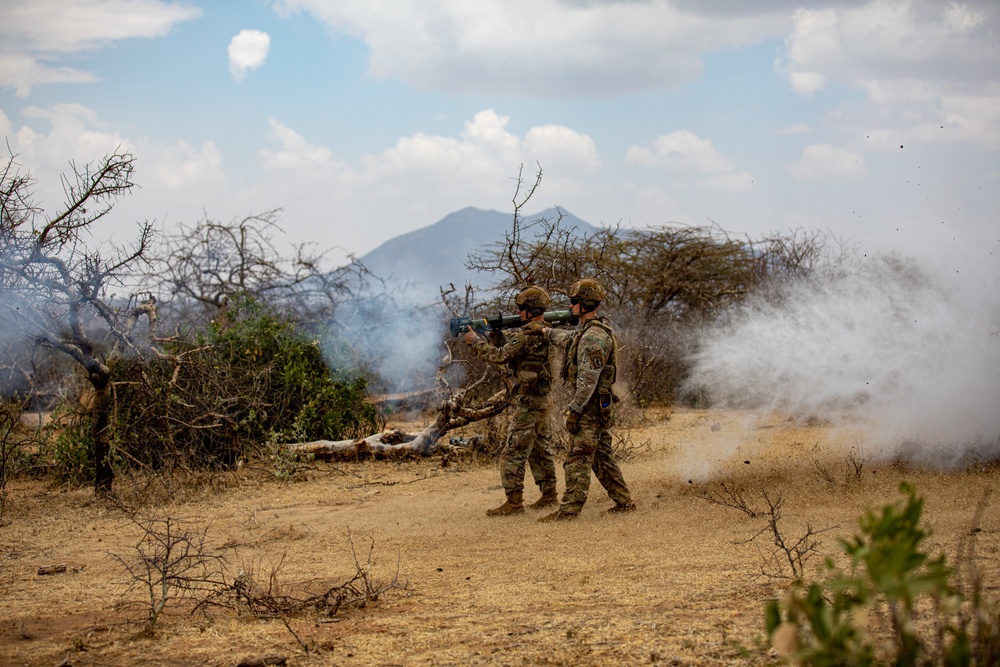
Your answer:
[766,482,1000,667]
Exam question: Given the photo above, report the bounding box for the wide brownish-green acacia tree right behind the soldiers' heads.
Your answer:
[466,164,829,401]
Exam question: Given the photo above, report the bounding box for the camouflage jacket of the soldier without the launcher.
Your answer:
[549,317,618,412]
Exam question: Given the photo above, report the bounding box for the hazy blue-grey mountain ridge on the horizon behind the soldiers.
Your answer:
[360,206,595,303]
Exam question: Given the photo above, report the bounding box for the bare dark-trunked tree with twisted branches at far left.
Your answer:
[0,150,156,493]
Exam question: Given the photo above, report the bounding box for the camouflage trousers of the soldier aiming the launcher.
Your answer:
[500,394,556,496]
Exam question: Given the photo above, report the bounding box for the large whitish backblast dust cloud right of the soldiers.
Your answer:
[688,256,1000,469]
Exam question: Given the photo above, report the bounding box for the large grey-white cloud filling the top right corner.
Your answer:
[776,0,1000,144]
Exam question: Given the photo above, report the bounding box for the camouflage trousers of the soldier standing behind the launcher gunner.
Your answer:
[559,398,632,514]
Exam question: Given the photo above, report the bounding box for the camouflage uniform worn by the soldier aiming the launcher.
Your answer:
[472,326,557,506]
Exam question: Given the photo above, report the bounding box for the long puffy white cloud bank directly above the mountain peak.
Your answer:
[255,109,600,248]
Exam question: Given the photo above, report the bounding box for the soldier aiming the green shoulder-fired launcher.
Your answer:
[465,286,559,516]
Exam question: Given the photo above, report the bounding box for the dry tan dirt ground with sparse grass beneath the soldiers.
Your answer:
[0,410,1000,666]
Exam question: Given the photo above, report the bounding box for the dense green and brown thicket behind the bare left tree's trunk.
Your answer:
[62,298,379,478]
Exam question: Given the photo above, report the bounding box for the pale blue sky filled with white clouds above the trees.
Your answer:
[0,0,1000,276]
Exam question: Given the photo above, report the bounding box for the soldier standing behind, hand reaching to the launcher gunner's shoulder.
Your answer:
[533,278,635,521]
